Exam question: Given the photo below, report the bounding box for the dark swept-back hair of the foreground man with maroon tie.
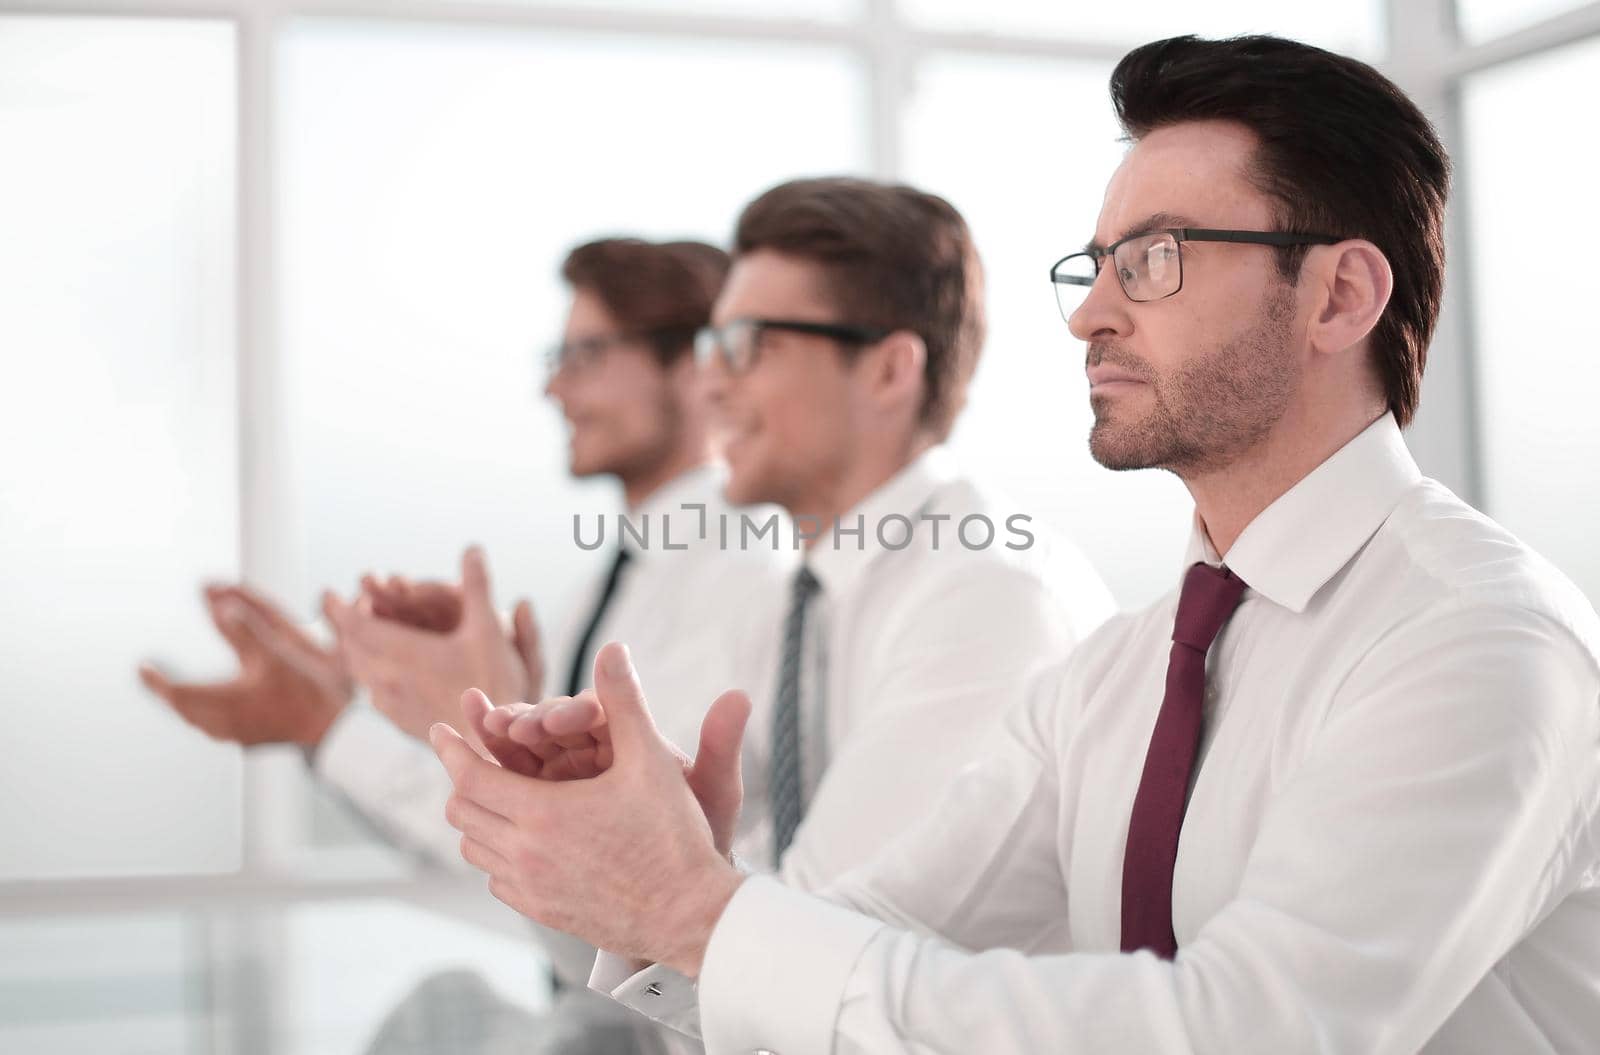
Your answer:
[1110,37,1450,424]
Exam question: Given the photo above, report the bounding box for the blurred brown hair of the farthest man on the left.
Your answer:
[562,239,728,363]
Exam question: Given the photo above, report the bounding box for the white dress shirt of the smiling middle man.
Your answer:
[590,447,1115,1028]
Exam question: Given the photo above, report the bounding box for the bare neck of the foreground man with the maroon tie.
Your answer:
[1178,405,1389,557]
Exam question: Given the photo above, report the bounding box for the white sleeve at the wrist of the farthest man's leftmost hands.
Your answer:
[310,700,474,874]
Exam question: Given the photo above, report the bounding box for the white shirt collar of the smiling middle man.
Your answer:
[805,445,960,597]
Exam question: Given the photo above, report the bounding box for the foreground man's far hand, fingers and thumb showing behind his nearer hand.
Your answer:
[461,668,747,856]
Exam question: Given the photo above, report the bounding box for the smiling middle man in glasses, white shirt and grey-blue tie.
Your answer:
[684,179,1112,889]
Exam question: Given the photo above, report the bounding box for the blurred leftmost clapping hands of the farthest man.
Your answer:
[139,586,352,748]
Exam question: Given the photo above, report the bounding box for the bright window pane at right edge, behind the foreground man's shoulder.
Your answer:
[1458,40,1600,604]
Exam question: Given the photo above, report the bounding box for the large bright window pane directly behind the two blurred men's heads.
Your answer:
[275,19,867,627]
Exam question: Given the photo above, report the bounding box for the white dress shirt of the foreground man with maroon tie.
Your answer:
[608,416,1600,1055]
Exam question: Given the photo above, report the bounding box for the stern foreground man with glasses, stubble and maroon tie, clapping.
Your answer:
[432,37,1600,1055]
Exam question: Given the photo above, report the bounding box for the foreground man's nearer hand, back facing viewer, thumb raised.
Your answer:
[430,642,750,977]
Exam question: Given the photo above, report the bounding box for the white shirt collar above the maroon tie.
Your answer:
[1184,415,1422,615]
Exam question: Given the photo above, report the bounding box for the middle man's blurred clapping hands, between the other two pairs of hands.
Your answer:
[323,546,544,740]
